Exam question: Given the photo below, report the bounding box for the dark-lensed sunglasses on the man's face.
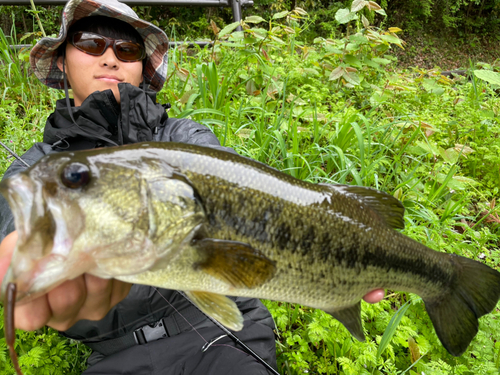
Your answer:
[69,31,146,62]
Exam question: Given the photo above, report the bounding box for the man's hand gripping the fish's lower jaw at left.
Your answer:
[0,232,132,331]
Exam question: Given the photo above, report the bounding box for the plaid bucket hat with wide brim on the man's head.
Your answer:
[30,0,168,91]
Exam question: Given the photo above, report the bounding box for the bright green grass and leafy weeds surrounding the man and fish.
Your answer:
[0,0,500,375]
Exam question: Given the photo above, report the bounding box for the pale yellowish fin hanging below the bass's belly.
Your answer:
[185,291,243,331]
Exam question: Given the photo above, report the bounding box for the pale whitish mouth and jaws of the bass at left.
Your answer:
[0,173,80,301]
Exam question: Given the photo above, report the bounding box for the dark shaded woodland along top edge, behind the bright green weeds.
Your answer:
[0,0,500,65]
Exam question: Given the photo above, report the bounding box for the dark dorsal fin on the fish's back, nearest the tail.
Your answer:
[321,184,405,229]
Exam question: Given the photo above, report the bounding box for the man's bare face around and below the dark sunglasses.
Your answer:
[57,43,143,107]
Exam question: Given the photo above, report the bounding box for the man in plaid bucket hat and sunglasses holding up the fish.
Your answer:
[0,0,383,375]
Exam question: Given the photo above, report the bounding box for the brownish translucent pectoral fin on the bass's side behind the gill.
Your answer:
[193,238,276,289]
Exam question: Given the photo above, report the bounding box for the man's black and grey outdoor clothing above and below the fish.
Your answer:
[0,84,276,375]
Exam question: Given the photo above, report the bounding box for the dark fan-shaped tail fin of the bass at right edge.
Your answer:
[424,255,500,356]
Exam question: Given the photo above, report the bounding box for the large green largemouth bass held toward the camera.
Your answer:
[0,143,500,356]
